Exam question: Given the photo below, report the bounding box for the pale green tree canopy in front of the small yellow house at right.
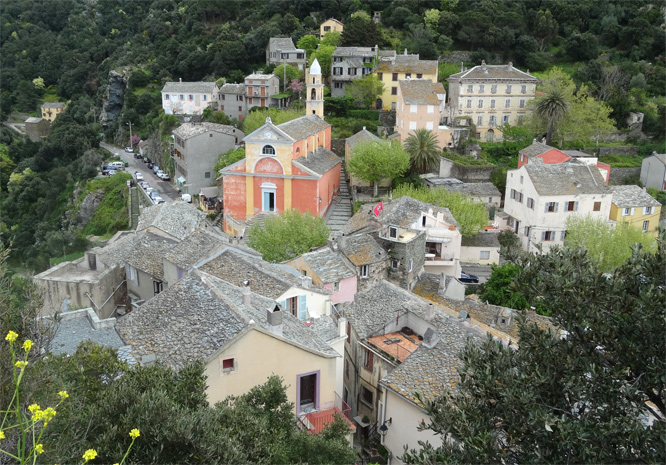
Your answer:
[565,215,656,271]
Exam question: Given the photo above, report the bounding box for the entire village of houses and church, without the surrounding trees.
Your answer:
[2,3,666,464]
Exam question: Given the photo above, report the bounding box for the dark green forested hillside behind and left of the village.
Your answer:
[0,0,666,271]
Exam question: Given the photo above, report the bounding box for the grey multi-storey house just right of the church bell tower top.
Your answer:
[329,46,379,97]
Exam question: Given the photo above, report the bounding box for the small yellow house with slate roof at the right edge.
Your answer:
[609,186,661,236]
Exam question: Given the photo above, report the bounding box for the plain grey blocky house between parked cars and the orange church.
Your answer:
[173,122,244,194]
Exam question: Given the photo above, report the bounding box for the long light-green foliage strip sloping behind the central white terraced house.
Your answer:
[393,184,488,237]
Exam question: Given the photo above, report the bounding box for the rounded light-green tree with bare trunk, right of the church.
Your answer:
[348,140,409,196]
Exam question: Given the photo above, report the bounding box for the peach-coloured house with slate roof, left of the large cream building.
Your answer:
[395,79,453,149]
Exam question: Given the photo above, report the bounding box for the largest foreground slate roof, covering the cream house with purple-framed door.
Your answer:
[116,272,337,368]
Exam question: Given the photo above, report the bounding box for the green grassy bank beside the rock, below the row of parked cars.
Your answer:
[78,172,132,236]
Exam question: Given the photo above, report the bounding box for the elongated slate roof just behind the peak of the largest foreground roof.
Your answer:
[197,249,296,299]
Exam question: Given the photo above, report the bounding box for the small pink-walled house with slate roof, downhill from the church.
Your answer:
[286,242,358,305]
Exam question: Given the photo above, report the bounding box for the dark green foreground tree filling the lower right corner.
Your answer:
[402,231,666,464]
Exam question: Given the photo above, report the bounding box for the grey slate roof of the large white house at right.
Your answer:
[520,161,610,195]
